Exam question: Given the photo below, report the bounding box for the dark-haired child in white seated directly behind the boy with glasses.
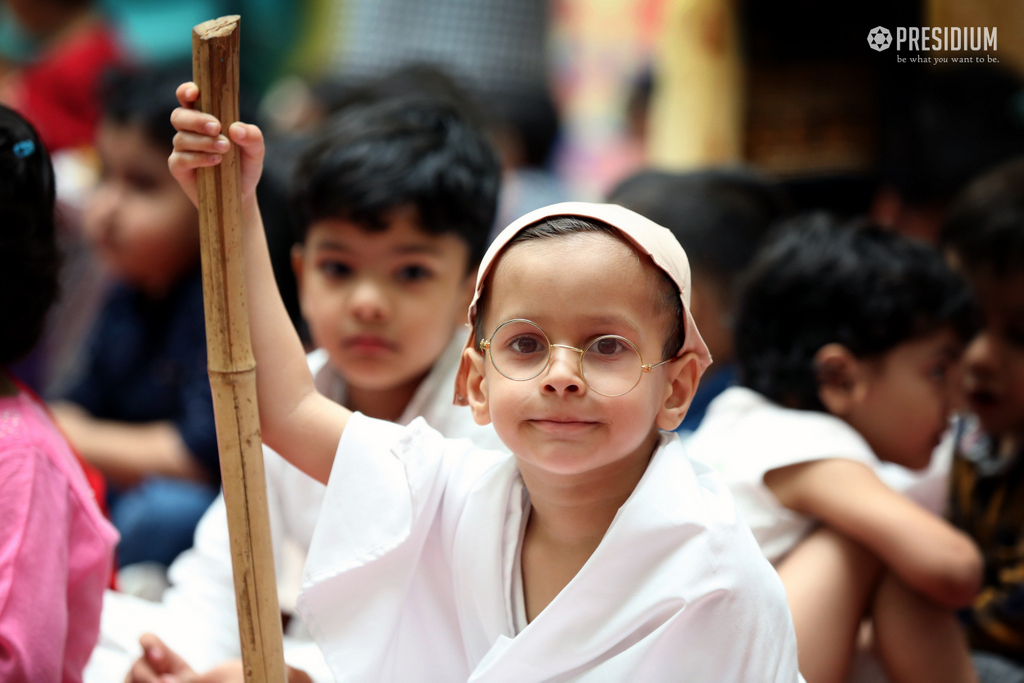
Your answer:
[88,96,502,681]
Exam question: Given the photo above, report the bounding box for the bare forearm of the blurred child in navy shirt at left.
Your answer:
[50,401,207,485]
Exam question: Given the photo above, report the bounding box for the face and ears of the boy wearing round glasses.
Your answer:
[466,233,696,474]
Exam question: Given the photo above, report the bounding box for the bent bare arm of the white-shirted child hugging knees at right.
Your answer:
[765,459,982,607]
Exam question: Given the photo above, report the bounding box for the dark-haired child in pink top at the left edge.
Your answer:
[0,106,118,682]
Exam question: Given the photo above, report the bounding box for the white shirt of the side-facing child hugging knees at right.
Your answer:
[686,387,949,564]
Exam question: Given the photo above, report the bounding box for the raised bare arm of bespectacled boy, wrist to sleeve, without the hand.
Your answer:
[236,200,349,481]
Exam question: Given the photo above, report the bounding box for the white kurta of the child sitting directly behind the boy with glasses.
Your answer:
[85,330,504,683]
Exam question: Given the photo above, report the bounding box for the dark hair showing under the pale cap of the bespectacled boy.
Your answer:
[473,216,686,359]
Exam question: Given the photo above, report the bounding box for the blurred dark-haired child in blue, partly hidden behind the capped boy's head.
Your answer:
[608,169,788,433]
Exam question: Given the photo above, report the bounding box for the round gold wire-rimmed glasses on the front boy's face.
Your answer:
[480,318,675,398]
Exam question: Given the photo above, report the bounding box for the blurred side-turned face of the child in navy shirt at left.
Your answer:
[83,121,200,296]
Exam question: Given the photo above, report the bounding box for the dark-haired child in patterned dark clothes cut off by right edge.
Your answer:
[942,160,1024,681]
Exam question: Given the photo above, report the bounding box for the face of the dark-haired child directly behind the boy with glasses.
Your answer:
[292,208,475,390]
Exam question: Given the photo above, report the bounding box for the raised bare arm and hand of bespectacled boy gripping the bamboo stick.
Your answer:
[168,83,351,482]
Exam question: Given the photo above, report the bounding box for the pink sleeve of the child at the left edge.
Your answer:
[0,446,69,683]
